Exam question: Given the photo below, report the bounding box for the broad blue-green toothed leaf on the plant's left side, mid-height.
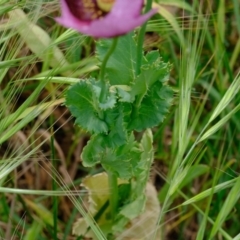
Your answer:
[66,81,108,133]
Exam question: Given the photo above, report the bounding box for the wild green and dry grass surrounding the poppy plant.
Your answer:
[0,0,240,240]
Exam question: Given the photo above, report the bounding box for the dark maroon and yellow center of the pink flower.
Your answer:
[66,0,115,21]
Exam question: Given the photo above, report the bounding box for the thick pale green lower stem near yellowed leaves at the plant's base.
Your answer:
[108,172,118,221]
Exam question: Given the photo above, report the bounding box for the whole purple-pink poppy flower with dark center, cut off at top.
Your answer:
[56,0,156,37]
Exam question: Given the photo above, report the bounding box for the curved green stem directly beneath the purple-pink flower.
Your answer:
[99,37,118,102]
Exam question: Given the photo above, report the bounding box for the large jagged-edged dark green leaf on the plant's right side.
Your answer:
[129,54,172,131]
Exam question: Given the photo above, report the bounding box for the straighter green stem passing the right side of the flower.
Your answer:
[136,0,153,75]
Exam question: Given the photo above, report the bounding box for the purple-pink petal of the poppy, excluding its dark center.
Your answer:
[56,0,156,37]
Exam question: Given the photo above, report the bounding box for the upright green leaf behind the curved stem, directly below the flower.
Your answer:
[97,33,137,85]
